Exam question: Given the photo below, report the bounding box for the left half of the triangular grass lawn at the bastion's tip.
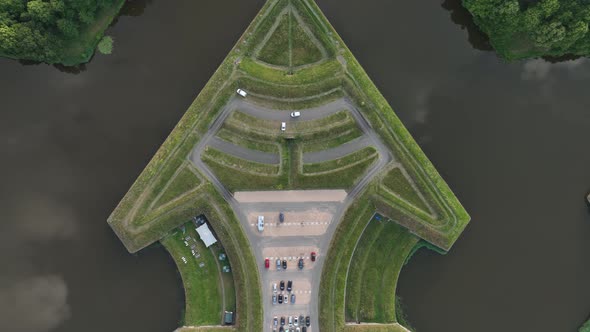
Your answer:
[258,13,291,66]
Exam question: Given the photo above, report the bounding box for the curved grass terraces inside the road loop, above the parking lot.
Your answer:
[202,111,378,192]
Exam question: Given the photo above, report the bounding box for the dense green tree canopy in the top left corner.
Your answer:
[0,0,122,63]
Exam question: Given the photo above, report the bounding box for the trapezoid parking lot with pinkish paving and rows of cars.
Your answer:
[236,190,343,332]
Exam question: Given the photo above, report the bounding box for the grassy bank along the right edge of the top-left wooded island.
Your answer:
[59,0,125,66]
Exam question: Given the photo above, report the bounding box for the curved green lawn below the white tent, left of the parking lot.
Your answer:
[160,222,235,326]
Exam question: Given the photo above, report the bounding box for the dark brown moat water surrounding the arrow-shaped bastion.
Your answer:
[0,0,590,332]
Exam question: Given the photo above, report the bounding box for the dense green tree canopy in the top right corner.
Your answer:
[463,0,590,60]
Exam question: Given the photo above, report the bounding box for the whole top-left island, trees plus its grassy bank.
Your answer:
[0,0,125,66]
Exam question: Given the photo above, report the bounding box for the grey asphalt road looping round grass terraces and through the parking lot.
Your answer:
[190,98,393,331]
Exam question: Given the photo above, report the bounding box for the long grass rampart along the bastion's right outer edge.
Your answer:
[286,0,470,250]
